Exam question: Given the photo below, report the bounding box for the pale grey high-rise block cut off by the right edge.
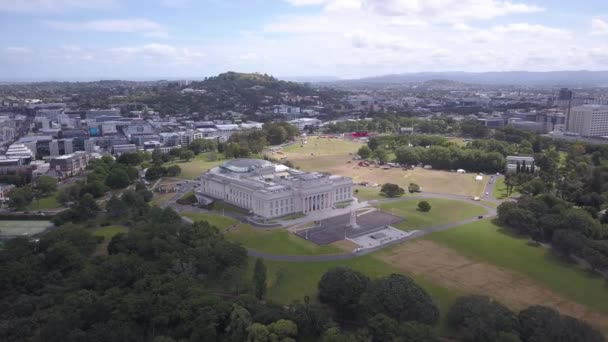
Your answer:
[567,105,608,137]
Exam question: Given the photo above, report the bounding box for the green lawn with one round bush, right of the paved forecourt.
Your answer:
[380,198,486,231]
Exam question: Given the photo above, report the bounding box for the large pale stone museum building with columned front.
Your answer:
[197,159,353,219]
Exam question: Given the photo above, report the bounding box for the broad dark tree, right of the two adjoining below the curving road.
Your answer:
[361,274,439,324]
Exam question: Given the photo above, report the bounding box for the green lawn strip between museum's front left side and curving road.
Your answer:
[226,224,344,255]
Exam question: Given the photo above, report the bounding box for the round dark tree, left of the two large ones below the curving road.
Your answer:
[318,267,369,316]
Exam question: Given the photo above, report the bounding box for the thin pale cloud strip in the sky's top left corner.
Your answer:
[0,0,117,13]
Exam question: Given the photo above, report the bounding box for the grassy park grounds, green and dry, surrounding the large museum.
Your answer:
[146,136,608,336]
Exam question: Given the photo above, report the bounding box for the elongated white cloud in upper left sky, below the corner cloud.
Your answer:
[47,18,168,38]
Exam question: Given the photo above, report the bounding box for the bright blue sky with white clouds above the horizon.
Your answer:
[0,0,608,80]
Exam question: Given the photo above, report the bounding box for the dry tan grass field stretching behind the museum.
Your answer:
[282,137,488,196]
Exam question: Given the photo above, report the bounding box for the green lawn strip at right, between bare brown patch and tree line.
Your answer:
[428,220,608,313]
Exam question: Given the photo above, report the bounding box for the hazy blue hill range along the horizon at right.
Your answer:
[342,70,608,87]
